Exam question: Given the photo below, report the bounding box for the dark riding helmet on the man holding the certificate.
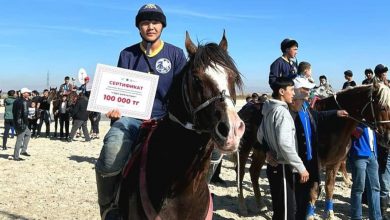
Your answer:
[135,4,167,28]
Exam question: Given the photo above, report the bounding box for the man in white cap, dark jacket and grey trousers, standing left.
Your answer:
[12,88,31,161]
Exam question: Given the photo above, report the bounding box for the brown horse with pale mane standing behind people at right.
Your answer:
[239,82,390,219]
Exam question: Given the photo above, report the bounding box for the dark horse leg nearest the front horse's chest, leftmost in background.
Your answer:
[236,147,253,215]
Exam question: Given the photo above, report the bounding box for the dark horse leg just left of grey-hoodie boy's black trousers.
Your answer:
[249,148,267,212]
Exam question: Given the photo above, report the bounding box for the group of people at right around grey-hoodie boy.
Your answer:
[258,39,390,219]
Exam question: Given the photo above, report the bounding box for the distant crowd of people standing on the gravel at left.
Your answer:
[2,76,101,161]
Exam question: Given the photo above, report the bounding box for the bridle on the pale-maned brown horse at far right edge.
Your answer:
[333,86,390,135]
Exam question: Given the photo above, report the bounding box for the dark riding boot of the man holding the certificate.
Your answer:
[96,170,121,220]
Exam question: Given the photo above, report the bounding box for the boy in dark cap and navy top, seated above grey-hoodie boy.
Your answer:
[268,38,298,88]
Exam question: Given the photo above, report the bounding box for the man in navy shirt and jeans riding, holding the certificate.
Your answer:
[96,4,186,219]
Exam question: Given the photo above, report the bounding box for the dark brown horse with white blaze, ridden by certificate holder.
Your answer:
[119,33,245,220]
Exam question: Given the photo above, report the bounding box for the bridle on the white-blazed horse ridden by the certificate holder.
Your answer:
[169,67,236,133]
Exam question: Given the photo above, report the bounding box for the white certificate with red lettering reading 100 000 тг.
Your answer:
[87,64,158,119]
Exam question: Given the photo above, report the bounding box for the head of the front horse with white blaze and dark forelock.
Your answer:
[169,32,245,153]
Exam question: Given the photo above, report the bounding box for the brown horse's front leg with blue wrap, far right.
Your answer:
[325,162,341,219]
